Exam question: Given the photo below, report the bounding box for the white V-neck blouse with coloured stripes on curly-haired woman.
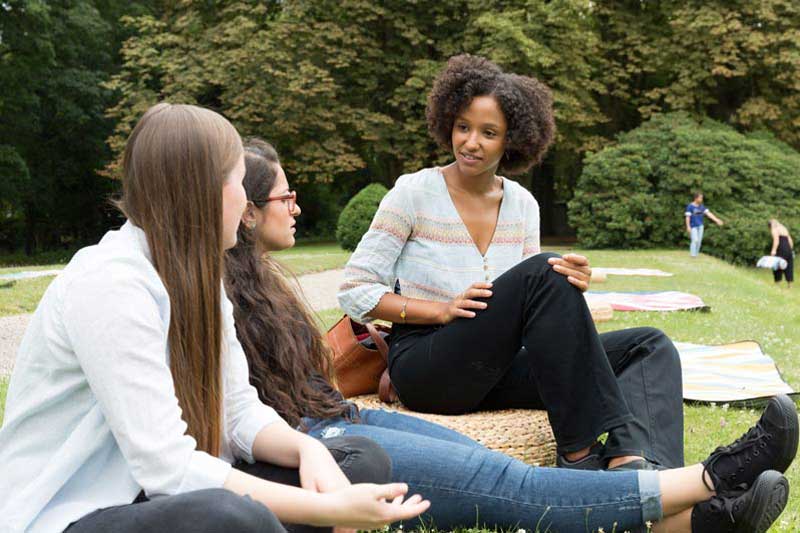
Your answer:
[338,168,540,322]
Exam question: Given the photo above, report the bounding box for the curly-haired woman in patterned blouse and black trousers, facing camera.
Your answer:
[339,54,683,469]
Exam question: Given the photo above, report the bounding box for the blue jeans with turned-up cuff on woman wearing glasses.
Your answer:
[305,409,662,533]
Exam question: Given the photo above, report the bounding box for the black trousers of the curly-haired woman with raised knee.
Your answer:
[389,254,683,467]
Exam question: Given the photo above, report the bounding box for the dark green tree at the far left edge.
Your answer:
[0,0,156,252]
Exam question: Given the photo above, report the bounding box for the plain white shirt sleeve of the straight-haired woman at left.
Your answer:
[62,263,231,496]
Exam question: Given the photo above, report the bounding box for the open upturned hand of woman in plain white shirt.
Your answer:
[324,483,430,529]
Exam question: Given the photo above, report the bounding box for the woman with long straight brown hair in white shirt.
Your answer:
[0,104,427,533]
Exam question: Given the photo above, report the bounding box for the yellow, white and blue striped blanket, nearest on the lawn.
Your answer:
[675,341,795,403]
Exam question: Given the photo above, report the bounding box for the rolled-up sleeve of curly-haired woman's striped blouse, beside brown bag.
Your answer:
[337,184,414,322]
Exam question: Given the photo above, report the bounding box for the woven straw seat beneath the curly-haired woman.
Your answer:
[350,394,556,466]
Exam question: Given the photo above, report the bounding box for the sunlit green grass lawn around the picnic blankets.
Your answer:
[0,245,800,533]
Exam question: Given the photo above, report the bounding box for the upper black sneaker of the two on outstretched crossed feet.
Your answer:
[703,394,798,494]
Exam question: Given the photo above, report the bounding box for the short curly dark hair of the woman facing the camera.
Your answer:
[425,54,556,174]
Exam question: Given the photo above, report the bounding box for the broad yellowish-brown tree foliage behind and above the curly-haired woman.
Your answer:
[106,0,800,241]
